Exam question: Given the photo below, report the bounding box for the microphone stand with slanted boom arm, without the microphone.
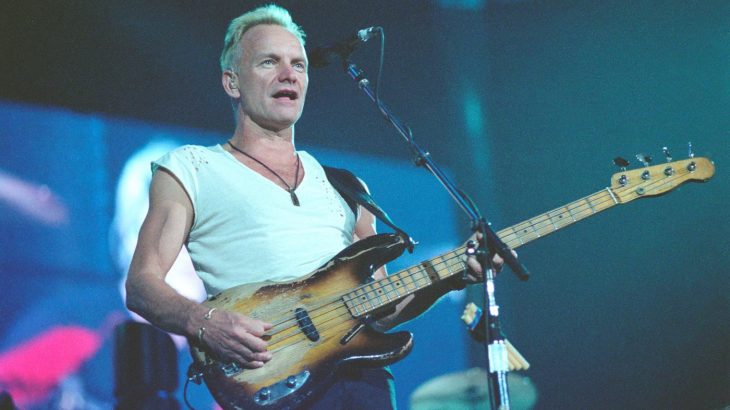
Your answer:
[343,59,529,410]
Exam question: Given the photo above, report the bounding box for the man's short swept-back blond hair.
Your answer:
[220,4,306,71]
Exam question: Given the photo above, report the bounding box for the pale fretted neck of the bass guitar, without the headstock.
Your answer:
[344,188,619,317]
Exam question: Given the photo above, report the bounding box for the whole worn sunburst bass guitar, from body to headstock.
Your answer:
[191,157,715,409]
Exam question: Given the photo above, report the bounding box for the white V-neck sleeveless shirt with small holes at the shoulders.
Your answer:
[152,145,355,294]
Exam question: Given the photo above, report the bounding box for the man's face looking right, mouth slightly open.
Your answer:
[238,24,309,131]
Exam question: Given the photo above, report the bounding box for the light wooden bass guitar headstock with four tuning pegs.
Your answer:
[611,154,715,203]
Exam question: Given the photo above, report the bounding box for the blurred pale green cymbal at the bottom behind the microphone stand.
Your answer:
[411,367,537,410]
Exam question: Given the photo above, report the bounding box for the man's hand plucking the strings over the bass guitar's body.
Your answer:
[195,310,272,369]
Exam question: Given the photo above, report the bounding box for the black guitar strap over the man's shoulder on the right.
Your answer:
[322,165,414,252]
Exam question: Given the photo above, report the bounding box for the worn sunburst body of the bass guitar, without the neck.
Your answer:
[192,235,412,409]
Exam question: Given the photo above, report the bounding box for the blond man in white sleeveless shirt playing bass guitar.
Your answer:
[126,5,500,409]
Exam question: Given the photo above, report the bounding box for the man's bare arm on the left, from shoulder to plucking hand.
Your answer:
[126,170,271,368]
